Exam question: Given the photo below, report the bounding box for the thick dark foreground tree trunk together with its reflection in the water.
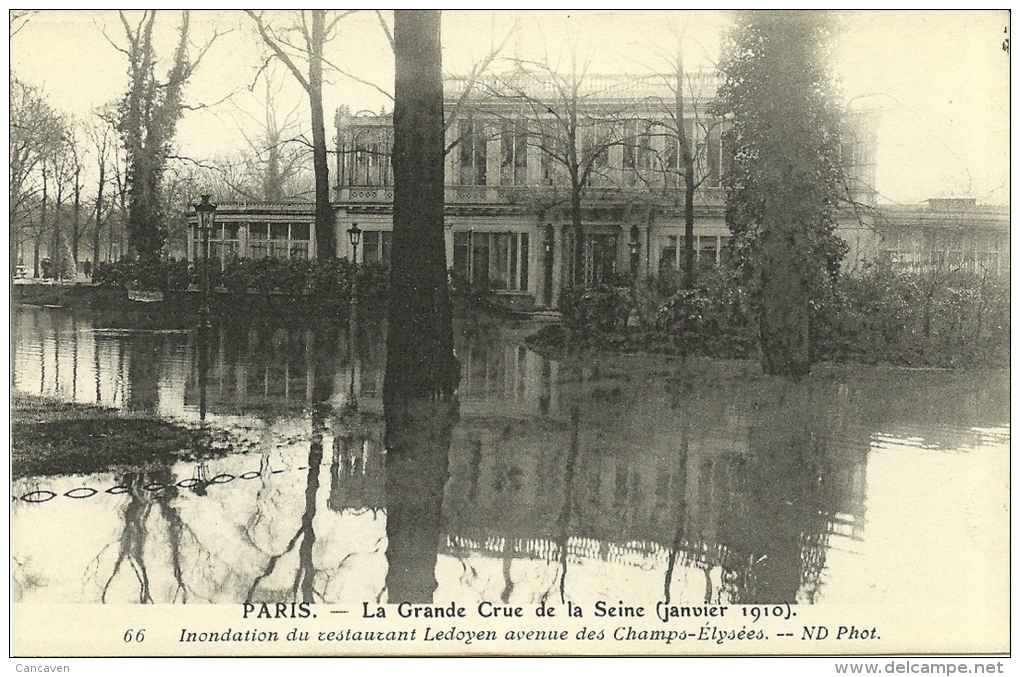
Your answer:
[383,10,459,604]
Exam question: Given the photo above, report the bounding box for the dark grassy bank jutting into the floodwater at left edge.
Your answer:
[11,393,222,479]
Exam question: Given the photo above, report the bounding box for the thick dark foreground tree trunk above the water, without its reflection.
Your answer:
[384,10,459,403]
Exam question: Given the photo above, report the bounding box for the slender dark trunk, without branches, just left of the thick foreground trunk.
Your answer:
[308,9,336,259]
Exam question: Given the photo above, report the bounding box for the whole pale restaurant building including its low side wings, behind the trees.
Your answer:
[188,73,1009,308]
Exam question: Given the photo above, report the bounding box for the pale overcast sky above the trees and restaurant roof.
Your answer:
[10,10,1010,204]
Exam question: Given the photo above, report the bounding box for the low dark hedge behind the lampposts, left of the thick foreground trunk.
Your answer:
[93,258,388,308]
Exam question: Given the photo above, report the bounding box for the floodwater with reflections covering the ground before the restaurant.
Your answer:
[11,307,1010,606]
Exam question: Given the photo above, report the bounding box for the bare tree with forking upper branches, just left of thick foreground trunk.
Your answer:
[245,9,359,258]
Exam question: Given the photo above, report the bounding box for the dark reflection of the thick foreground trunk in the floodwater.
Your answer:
[386,398,458,604]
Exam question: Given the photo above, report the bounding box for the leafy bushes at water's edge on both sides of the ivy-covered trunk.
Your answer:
[531,264,1010,367]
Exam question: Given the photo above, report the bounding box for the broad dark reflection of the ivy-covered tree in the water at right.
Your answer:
[681,378,868,604]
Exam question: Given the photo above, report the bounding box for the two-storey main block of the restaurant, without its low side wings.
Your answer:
[334,72,875,307]
